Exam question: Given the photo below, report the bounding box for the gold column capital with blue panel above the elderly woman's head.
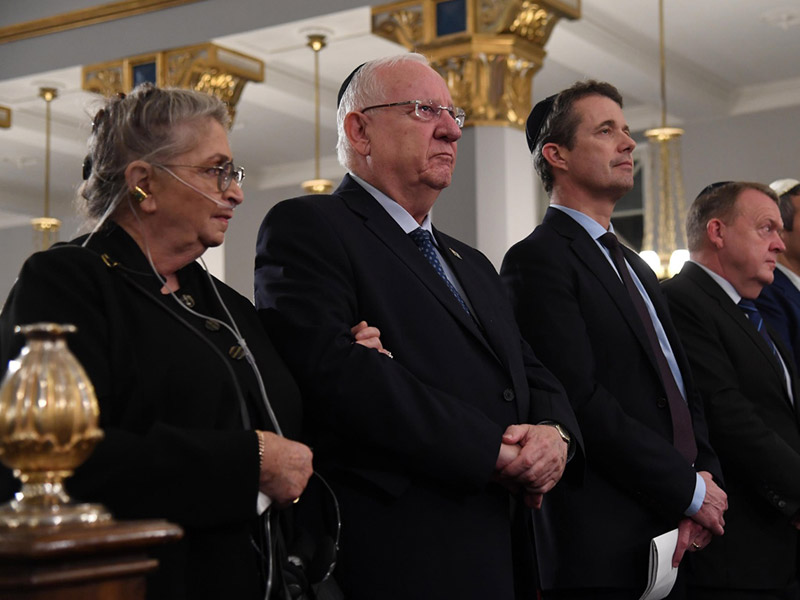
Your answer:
[81,42,264,122]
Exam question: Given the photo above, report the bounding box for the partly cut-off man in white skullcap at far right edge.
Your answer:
[756,179,800,372]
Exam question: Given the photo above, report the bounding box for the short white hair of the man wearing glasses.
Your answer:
[336,52,428,170]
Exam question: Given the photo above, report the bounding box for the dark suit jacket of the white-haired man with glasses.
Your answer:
[255,176,579,600]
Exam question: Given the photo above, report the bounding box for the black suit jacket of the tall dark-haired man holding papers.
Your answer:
[501,208,720,591]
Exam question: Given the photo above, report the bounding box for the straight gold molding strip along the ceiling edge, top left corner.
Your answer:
[0,0,198,44]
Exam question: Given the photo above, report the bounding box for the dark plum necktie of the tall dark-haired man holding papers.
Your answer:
[599,232,697,464]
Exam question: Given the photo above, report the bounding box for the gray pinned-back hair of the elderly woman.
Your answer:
[77,83,230,221]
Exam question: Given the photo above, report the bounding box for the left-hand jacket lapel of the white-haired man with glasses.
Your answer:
[335,175,494,354]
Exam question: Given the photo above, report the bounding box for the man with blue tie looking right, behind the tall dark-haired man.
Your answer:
[663,182,800,600]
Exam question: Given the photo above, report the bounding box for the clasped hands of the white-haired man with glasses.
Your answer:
[494,424,569,508]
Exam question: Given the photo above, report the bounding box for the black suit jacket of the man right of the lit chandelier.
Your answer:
[663,263,800,589]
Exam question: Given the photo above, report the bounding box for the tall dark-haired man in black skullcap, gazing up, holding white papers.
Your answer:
[501,81,727,600]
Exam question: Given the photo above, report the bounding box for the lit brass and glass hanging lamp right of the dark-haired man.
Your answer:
[640,0,689,279]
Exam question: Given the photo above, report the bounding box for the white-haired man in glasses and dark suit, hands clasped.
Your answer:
[256,54,581,600]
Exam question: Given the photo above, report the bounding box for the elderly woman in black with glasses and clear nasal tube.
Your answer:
[0,84,379,600]
